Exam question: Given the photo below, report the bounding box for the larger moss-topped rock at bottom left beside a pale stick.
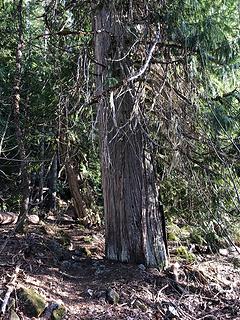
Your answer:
[17,288,46,317]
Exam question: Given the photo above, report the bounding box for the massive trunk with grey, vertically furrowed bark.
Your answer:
[94,6,167,266]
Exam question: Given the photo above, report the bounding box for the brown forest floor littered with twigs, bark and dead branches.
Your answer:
[0,216,240,320]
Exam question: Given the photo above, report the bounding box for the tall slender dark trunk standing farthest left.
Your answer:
[13,0,29,232]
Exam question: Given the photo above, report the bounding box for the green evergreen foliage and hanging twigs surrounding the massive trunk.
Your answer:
[0,0,240,245]
